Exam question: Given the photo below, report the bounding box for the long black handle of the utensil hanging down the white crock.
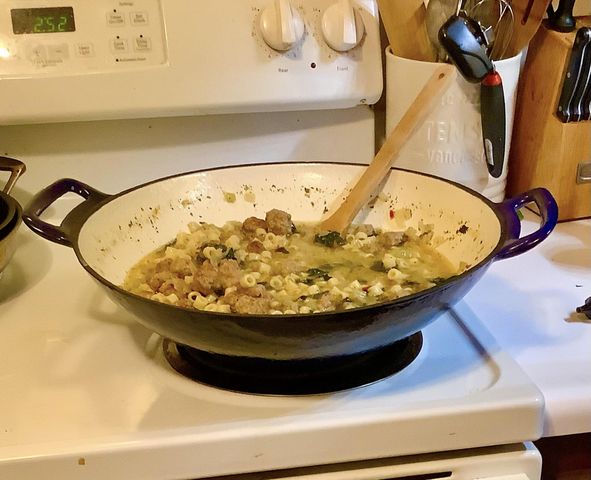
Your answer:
[480,71,505,178]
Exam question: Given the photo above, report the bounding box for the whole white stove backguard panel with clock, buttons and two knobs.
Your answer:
[0,0,382,125]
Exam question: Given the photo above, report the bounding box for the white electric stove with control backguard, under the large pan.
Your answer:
[0,0,543,480]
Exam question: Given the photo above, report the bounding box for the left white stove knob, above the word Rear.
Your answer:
[260,0,304,52]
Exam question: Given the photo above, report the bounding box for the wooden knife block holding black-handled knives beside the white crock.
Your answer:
[507,17,591,220]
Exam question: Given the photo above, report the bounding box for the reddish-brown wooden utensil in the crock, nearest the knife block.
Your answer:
[504,0,550,58]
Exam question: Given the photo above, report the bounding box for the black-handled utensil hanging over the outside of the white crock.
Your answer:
[439,13,505,178]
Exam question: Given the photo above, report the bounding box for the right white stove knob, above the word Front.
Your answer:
[322,0,364,52]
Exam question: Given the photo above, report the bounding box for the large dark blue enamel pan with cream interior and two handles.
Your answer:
[24,163,557,360]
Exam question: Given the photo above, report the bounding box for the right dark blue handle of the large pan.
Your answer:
[495,188,558,260]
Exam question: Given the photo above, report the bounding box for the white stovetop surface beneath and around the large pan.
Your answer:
[0,214,543,474]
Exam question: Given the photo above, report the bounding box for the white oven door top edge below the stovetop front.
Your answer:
[230,442,542,480]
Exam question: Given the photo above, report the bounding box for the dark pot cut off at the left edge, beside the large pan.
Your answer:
[0,156,25,273]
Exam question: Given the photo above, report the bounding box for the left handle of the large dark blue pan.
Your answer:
[23,178,110,247]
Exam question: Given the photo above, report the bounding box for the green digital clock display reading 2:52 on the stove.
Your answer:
[10,7,76,35]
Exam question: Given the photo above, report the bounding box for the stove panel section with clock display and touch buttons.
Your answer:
[0,0,167,77]
